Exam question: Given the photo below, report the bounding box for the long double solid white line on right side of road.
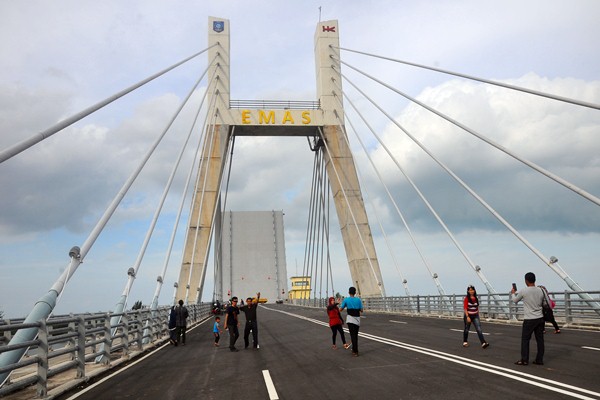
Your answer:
[265,307,600,400]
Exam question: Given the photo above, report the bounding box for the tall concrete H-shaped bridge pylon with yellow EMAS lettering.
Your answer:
[176,17,385,303]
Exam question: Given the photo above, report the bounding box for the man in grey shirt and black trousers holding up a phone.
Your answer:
[511,272,545,365]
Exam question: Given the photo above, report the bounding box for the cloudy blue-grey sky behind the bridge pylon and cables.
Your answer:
[0,0,600,317]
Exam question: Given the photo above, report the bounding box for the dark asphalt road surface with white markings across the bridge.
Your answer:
[61,304,600,400]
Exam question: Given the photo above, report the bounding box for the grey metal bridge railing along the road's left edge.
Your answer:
[0,303,211,397]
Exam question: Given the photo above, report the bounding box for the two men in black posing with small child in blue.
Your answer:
[213,292,260,352]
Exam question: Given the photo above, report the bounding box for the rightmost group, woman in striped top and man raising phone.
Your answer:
[463,272,560,365]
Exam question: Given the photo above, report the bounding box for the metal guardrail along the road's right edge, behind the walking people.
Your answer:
[291,291,600,327]
